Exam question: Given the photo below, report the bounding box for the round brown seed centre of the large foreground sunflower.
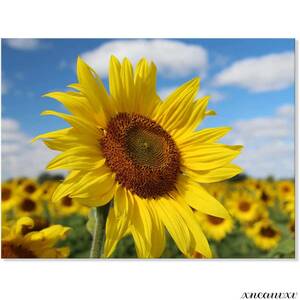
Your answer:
[101,113,179,198]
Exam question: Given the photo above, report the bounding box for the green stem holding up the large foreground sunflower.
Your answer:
[90,203,110,258]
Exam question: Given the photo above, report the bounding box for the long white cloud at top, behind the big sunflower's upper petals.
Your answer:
[81,40,208,77]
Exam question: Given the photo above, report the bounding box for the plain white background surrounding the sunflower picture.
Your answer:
[0,0,300,300]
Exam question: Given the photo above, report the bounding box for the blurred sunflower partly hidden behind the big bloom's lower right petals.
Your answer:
[196,212,234,241]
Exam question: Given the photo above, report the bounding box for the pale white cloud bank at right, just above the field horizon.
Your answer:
[223,104,295,178]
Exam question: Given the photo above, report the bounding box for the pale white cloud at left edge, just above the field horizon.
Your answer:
[1,118,57,179]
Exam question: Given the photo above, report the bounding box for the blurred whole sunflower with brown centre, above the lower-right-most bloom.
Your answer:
[226,190,262,222]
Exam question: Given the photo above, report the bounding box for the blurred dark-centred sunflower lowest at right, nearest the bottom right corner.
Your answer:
[246,219,281,250]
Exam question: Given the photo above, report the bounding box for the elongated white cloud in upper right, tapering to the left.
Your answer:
[214,52,294,92]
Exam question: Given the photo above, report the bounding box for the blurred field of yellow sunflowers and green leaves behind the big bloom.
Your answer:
[1,176,295,258]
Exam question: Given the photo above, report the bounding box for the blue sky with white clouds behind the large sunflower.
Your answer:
[1,39,295,178]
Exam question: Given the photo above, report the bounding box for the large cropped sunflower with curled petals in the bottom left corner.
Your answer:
[1,217,70,258]
